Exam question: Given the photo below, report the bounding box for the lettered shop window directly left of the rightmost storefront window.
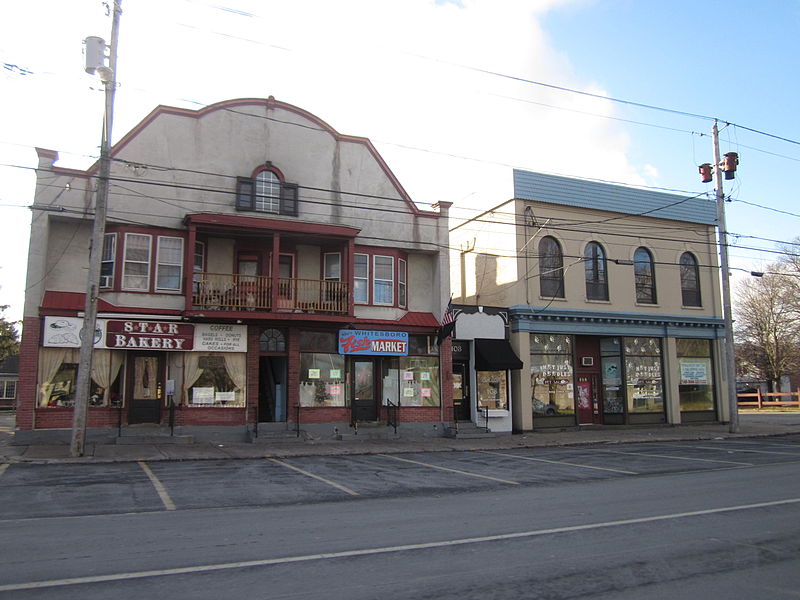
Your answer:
[624,337,664,413]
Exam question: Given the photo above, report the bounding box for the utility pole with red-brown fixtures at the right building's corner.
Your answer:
[712,119,739,433]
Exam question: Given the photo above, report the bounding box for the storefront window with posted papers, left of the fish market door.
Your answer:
[300,352,348,407]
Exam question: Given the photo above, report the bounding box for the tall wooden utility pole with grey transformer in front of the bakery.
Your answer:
[70,0,122,457]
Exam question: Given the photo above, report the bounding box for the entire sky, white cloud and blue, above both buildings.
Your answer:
[0,0,800,319]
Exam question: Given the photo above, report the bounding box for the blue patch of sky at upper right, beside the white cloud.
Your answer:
[542,0,800,266]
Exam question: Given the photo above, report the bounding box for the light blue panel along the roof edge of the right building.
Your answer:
[514,169,717,225]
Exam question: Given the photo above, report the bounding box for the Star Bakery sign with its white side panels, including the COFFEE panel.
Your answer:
[42,317,247,352]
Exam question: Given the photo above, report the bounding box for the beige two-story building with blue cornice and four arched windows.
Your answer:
[450,170,728,431]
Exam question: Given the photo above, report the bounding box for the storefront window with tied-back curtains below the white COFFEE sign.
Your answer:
[184,352,247,408]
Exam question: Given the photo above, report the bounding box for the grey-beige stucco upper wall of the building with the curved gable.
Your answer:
[25,100,449,320]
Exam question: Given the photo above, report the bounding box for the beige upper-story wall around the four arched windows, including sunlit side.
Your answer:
[450,200,721,317]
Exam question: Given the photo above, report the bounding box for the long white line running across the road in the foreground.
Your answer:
[0,498,800,592]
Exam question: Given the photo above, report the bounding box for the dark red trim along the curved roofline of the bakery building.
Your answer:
[36,96,441,217]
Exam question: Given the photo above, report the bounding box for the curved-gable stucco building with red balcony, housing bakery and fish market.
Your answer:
[17,97,450,440]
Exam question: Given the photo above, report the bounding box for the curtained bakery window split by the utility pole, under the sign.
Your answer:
[38,348,123,408]
